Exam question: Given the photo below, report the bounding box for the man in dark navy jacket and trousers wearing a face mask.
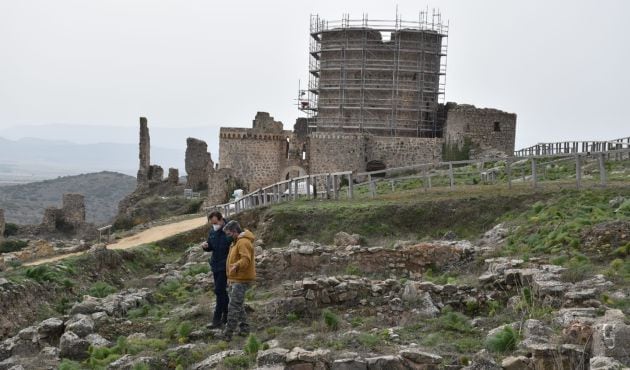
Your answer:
[201,212,232,329]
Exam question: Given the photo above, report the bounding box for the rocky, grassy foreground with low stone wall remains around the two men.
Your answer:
[0,189,630,370]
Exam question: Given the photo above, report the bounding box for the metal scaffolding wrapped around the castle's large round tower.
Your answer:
[298,10,448,137]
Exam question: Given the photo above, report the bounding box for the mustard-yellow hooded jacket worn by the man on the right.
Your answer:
[226,229,256,283]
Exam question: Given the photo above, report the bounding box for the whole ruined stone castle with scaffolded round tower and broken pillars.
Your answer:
[123,12,516,204]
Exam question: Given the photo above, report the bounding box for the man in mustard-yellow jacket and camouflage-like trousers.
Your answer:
[218,221,256,341]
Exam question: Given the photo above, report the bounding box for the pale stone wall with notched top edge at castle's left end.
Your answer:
[219,127,292,191]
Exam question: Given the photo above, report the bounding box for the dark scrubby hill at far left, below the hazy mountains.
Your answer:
[0,172,136,224]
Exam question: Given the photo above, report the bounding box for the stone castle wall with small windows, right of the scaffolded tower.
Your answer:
[444,104,516,155]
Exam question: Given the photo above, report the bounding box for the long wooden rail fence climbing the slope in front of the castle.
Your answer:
[206,148,630,216]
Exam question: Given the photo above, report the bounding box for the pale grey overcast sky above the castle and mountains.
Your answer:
[0,0,630,147]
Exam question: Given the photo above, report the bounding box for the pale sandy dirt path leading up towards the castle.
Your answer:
[24,217,207,266]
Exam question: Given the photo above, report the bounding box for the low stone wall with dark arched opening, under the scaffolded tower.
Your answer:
[366,136,443,168]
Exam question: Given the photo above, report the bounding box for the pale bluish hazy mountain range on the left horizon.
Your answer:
[0,123,225,186]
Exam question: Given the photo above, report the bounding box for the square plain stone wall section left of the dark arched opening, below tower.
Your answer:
[308,132,365,174]
